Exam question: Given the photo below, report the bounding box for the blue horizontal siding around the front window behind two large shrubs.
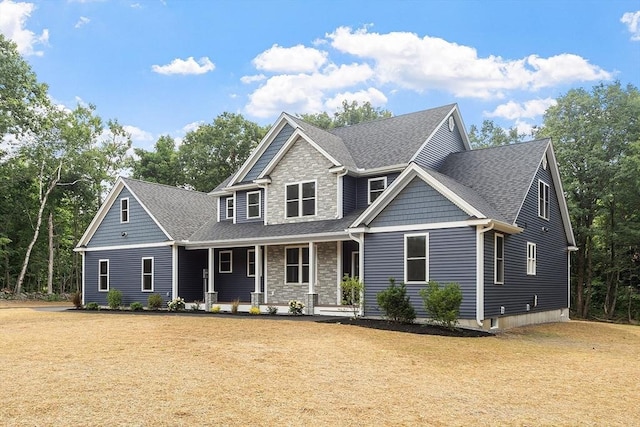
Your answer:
[364,227,476,318]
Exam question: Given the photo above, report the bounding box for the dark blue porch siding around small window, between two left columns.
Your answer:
[214,247,255,302]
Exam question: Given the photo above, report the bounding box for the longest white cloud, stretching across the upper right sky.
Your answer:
[326,27,611,99]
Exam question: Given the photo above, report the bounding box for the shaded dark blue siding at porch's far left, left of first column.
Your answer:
[178,247,209,302]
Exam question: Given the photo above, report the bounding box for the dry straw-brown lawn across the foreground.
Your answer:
[0,305,640,426]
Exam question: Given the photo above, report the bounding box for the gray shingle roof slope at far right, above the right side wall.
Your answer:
[439,139,549,224]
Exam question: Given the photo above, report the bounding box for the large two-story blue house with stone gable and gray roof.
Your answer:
[76,104,575,329]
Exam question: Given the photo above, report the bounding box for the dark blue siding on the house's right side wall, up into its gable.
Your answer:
[484,162,569,318]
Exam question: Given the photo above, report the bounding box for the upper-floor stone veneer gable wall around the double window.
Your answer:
[267,139,338,224]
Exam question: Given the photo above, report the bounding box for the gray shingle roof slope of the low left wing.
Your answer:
[123,178,216,240]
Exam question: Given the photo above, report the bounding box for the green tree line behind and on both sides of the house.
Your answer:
[0,35,640,320]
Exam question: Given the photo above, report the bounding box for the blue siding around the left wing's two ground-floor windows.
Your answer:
[84,246,172,306]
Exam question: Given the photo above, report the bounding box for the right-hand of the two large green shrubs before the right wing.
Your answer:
[420,282,462,329]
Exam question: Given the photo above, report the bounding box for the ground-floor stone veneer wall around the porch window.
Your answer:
[267,242,338,305]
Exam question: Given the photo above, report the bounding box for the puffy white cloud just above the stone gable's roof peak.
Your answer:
[246,64,373,117]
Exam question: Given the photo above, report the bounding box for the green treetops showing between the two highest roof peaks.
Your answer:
[298,99,393,129]
